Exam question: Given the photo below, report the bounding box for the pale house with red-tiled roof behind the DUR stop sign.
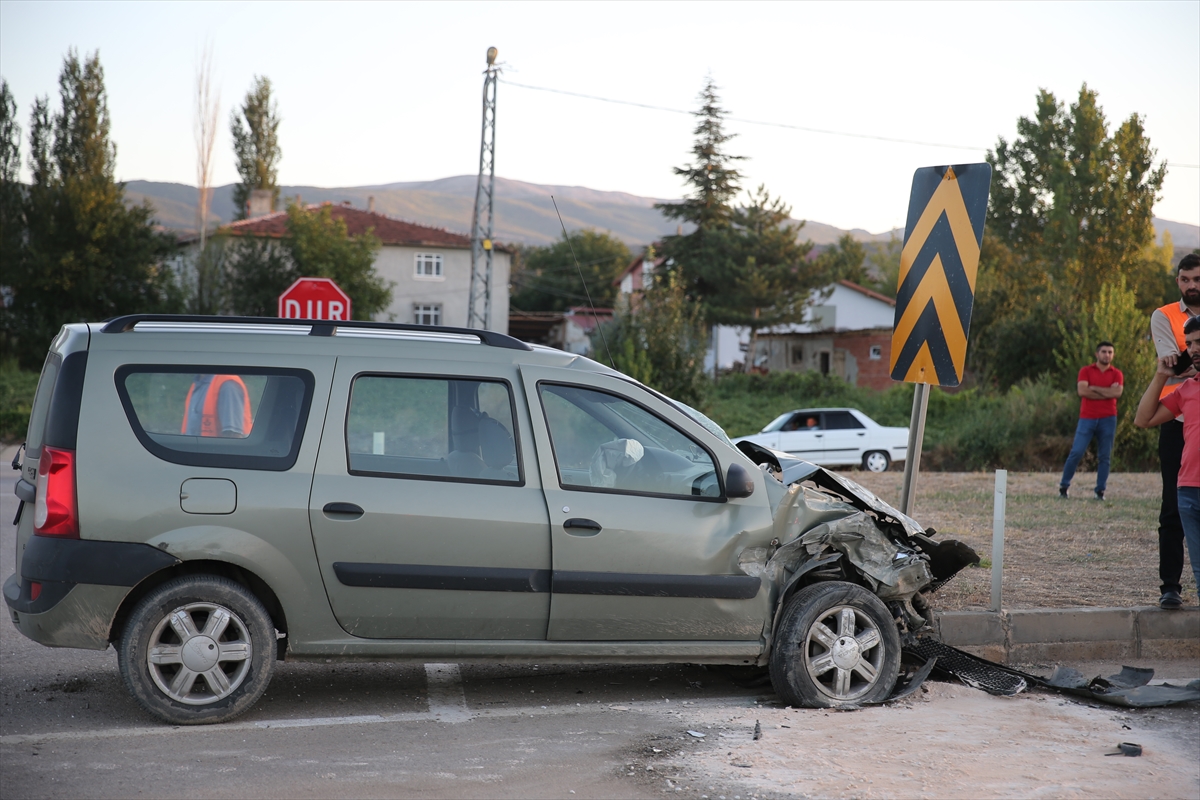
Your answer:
[184,203,512,333]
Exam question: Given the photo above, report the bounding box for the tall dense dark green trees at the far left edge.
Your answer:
[5,50,182,368]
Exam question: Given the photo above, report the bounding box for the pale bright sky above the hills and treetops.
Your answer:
[0,0,1200,233]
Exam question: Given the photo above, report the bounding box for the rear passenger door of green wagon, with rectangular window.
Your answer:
[308,359,551,639]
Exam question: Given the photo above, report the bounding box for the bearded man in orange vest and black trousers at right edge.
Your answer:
[1150,253,1200,608]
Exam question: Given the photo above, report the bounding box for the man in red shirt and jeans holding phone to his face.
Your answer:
[1133,317,1200,608]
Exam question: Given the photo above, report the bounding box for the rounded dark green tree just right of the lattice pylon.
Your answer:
[511,230,631,311]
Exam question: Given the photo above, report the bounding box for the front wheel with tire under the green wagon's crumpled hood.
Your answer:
[770,581,900,709]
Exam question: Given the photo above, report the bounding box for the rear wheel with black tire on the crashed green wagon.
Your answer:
[118,575,276,724]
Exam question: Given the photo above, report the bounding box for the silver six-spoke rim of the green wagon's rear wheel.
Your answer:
[146,603,253,705]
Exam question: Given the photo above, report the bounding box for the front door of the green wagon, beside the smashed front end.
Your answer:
[521,367,772,642]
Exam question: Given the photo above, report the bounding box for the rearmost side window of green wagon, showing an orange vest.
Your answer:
[116,365,314,471]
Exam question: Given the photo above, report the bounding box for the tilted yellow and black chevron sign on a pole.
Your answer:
[892,164,991,386]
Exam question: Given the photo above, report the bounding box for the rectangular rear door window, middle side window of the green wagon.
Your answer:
[346,374,522,483]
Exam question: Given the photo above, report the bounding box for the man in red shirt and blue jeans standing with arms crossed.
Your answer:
[1058,342,1124,500]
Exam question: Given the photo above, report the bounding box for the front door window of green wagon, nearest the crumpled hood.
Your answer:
[538,384,721,499]
